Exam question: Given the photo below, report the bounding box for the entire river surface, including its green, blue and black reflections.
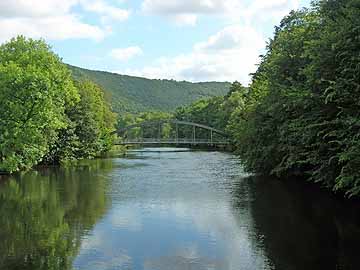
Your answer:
[0,148,360,270]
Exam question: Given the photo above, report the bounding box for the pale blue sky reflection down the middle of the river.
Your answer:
[74,149,270,270]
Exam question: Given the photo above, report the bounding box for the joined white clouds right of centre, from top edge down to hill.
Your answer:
[120,0,300,82]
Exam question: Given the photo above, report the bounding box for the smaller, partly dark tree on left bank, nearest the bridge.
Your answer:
[46,81,116,163]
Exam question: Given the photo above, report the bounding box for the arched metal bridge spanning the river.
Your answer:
[114,119,230,147]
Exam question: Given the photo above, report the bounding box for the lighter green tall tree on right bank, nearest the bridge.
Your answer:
[229,10,313,175]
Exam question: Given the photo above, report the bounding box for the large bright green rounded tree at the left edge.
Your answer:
[0,36,79,172]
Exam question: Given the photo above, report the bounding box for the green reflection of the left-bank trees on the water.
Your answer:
[0,161,112,270]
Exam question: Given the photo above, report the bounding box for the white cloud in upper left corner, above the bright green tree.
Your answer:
[0,0,129,42]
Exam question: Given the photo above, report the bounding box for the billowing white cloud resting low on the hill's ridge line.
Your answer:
[120,25,265,84]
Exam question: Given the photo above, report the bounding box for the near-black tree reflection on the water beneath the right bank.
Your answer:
[233,177,360,270]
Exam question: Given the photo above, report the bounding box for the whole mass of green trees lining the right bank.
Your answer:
[178,0,360,196]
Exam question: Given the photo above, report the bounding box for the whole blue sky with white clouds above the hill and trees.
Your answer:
[0,0,310,85]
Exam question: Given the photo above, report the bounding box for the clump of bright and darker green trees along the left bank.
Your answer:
[0,36,115,172]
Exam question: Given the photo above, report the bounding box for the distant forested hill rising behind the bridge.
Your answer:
[69,65,230,113]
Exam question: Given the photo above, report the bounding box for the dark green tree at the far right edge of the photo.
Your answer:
[305,0,360,196]
